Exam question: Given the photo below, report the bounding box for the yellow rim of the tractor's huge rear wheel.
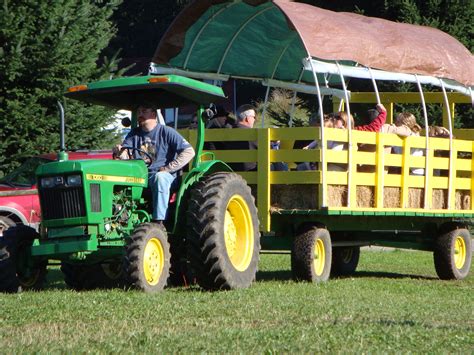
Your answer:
[224,195,254,271]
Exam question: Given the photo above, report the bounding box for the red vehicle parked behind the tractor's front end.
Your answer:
[0,150,112,236]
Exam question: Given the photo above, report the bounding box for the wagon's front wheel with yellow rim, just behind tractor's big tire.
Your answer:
[291,226,332,282]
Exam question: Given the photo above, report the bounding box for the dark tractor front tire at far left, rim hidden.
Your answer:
[0,225,47,292]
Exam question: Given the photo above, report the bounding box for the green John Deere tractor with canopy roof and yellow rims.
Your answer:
[0,75,260,292]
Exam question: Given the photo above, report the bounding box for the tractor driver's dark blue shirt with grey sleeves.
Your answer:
[122,125,191,174]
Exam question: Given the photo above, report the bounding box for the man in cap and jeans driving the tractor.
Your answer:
[114,106,195,225]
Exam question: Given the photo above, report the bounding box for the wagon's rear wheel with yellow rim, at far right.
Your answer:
[433,227,472,280]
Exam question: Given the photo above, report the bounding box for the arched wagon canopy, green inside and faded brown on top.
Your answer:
[152,0,474,91]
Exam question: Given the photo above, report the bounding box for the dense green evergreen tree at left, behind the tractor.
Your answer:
[0,0,120,177]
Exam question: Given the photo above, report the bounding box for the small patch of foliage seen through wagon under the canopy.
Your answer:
[255,88,310,127]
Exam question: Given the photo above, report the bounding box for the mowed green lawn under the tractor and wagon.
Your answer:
[0,250,474,354]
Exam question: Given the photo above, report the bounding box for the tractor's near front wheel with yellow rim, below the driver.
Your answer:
[125,223,171,293]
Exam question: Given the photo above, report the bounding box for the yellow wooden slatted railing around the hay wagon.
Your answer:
[181,127,474,231]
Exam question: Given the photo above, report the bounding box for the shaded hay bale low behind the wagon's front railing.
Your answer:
[270,185,319,210]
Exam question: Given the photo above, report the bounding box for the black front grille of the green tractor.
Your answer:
[39,186,86,220]
